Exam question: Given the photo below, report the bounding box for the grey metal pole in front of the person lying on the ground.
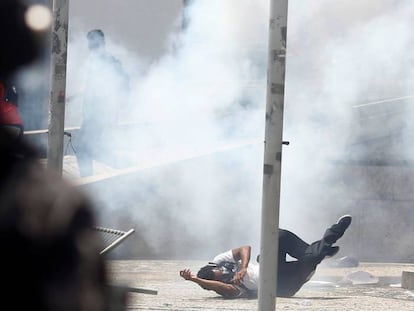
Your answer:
[258,0,287,311]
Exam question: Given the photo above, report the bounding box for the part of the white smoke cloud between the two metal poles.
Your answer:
[68,1,267,256]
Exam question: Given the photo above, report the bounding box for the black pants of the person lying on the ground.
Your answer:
[277,225,336,297]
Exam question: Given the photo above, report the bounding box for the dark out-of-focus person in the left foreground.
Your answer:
[0,0,124,311]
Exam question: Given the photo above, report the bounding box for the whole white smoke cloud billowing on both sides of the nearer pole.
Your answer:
[60,0,413,257]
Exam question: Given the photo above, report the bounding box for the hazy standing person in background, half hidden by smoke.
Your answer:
[75,29,129,176]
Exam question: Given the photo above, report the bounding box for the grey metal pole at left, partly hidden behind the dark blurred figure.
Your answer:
[47,0,69,174]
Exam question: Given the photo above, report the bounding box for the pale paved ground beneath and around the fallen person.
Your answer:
[109,260,414,311]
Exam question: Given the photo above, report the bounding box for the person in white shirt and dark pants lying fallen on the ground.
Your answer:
[180,215,352,298]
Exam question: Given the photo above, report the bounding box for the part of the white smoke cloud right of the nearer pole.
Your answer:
[281,0,413,260]
